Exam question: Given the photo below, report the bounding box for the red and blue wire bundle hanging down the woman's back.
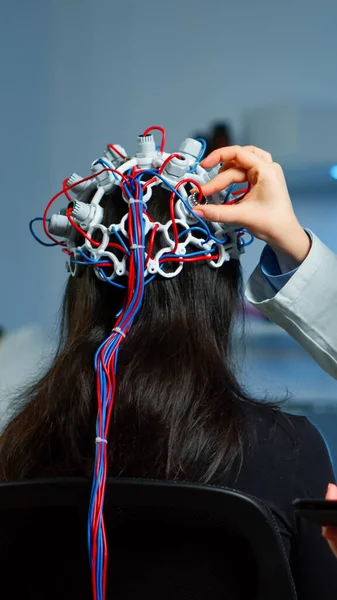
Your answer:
[88,176,145,600]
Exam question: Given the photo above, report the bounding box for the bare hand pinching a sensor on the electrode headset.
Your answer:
[195,146,311,264]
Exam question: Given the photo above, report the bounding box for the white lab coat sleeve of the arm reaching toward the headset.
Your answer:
[245,232,337,379]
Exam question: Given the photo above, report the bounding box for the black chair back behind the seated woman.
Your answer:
[0,478,296,600]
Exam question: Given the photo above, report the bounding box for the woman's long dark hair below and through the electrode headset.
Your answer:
[0,187,272,482]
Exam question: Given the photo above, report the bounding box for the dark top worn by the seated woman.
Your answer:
[219,410,337,600]
